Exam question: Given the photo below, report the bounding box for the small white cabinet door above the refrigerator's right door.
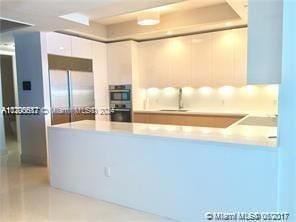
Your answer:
[72,37,92,59]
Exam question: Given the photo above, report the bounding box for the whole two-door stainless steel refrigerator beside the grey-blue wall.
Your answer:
[49,54,95,125]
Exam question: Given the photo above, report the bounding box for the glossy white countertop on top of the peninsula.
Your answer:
[51,120,277,147]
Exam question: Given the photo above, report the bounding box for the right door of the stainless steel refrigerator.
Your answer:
[69,71,95,122]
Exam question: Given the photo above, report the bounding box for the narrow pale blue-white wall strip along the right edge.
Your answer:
[278,0,296,217]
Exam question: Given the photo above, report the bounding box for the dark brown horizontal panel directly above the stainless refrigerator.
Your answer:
[48,55,93,72]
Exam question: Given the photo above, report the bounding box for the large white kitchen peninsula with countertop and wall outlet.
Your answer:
[48,120,277,222]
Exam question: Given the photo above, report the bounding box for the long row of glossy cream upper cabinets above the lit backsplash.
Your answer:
[139,28,247,88]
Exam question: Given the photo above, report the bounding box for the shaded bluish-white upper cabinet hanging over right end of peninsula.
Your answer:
[248,0,283,84]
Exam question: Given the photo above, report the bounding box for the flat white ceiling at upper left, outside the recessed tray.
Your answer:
[0,0,182,42]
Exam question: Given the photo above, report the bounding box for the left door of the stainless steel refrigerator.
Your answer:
[49,70,71,125]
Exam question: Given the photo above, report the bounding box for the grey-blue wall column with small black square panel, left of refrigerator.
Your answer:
[15,32,49,165]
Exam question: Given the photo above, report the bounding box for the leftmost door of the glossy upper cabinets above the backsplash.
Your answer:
[139,40,172,88]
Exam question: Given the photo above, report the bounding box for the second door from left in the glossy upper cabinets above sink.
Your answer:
[168,37,191,87]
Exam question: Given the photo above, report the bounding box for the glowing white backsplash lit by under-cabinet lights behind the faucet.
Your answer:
[135,85,278,115]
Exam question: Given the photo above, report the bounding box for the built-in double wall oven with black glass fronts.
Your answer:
[109,85,132,122]
